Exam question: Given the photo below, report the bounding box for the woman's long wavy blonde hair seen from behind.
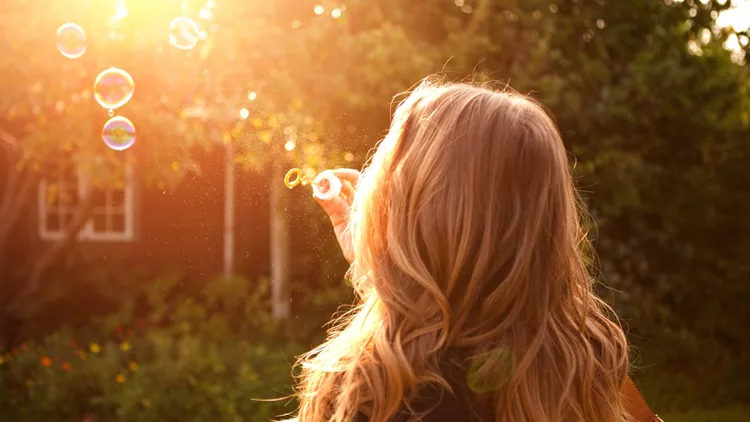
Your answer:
[297,80,628,422]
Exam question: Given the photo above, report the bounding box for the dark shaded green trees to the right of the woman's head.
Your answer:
[456,0,750,379]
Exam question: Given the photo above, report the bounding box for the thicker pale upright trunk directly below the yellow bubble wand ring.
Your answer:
[270,160,291,320]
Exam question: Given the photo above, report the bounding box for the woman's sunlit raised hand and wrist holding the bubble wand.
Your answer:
[315,169,360,264]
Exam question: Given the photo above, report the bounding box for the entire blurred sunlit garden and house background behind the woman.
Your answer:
[0,0,750,422]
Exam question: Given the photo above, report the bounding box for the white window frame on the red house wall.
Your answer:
[37,164,135,242]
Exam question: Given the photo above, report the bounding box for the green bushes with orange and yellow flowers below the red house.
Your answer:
[0,275,304,422]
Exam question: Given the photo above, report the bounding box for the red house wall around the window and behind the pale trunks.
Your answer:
[5,142,335,281]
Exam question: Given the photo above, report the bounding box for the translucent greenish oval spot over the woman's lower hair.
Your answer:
[466,348,516,394]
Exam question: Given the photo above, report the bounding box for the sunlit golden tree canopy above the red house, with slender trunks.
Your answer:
[0,0,490,326]
